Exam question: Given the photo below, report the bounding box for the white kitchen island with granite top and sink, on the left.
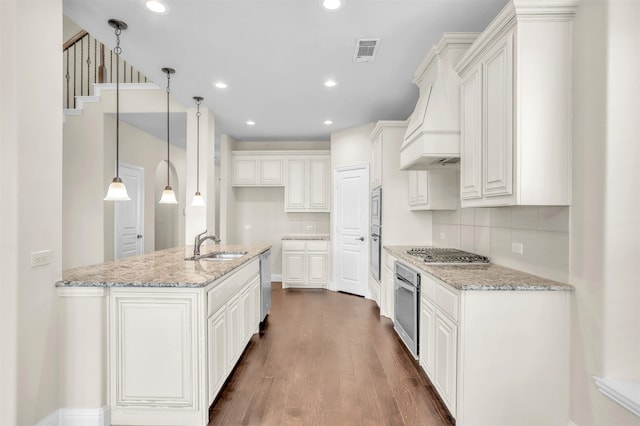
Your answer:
[56,245,270,426]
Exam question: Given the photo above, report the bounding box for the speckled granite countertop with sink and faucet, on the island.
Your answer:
[56,244,271,288]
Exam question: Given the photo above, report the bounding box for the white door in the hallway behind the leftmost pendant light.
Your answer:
[115,162,144,259]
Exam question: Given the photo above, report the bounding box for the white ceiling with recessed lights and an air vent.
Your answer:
[63,0,507,141]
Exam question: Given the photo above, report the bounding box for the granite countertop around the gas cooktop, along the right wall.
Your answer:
[384,246,574,291]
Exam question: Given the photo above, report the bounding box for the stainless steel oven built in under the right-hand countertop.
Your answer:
[393,262,420,359]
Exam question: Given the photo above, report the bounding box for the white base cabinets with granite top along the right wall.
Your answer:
[383,246,574,426]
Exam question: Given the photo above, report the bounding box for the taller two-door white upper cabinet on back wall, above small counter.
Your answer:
[284,155,331,212]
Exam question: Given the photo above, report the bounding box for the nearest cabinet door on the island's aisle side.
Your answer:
[207,305,228,404]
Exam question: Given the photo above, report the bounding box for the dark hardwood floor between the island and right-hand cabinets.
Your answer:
[209,283,454,426]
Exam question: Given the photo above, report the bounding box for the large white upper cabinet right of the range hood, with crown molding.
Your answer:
[456,0,576,207]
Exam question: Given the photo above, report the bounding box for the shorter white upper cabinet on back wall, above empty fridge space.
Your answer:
[231,151,284,186]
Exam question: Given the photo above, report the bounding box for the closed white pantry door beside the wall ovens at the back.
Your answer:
[333,166,370,297]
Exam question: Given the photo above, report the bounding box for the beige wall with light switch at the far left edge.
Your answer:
[0,0,62,425]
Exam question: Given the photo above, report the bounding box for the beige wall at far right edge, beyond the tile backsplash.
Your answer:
[570,0,640,426]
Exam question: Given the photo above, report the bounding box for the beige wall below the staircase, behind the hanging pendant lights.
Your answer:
[62,86,186,269]
